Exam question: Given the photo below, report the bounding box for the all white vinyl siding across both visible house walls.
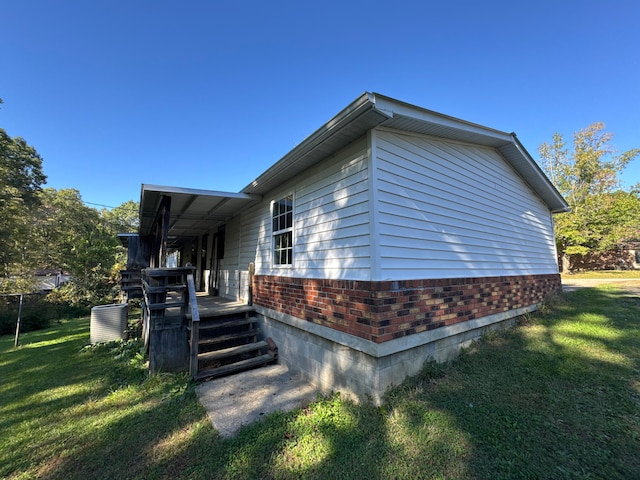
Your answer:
[221,129,558,299]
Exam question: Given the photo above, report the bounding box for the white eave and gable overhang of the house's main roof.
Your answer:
[242,92,569,212]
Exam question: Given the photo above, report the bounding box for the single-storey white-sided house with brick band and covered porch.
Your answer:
[131,93,568,403]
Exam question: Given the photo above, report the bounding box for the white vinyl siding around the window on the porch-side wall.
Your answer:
[241,137,371,280]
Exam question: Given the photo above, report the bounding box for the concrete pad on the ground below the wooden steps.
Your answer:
[196,365,317,438]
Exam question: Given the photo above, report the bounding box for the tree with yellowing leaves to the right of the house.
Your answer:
[538,123,640,268]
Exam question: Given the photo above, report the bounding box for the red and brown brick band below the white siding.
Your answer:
[253,274,562,343]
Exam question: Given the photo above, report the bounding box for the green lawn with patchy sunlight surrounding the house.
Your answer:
[0,286,640,479]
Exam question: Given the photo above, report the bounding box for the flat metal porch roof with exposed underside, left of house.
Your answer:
[140,184,261,237]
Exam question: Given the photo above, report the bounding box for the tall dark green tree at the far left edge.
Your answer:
[0,128,46,283]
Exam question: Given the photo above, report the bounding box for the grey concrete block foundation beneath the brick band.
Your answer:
[256,305,537,405]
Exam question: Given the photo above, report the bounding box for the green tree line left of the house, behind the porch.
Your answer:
[0,124,138,307]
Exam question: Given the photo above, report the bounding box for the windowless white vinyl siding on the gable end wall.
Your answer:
[375,130,557,280]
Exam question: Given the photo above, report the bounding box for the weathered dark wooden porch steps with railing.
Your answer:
[141,267,277,380]
